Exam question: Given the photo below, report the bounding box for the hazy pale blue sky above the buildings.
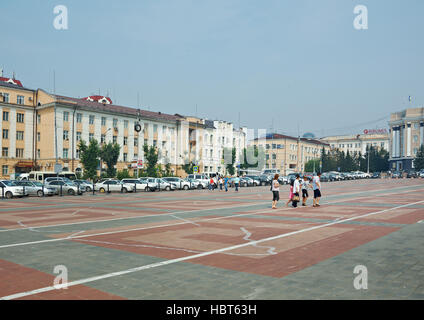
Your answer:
[0,0,424,136]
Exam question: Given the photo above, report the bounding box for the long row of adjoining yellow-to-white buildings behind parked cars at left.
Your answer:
[0,78,245,179]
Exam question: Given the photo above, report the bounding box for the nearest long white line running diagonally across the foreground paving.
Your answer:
[0,200,424,300]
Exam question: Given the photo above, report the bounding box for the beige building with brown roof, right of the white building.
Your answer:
[250,134,330,175]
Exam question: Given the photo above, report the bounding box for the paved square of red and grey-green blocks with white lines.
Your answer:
[0,179,424,299]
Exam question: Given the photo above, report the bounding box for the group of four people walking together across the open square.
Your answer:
[271,173,321,209]
